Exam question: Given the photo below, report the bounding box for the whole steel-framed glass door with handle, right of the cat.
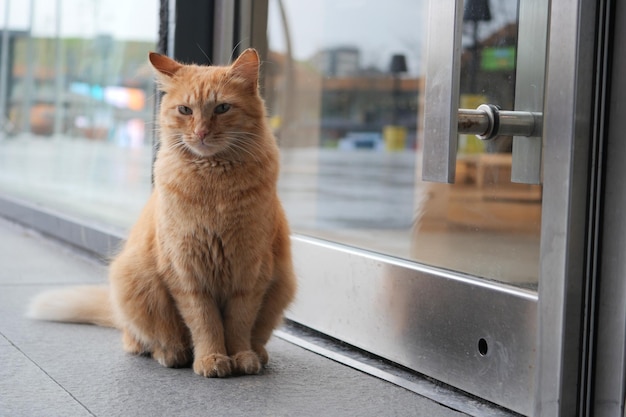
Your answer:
[234,0,597,415]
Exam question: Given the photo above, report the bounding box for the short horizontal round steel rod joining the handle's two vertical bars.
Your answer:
[457,104,542,140]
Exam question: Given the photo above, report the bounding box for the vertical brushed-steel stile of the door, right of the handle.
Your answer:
[534,0,605,416]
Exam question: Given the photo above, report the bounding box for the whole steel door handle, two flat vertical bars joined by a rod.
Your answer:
[422,0,549,184]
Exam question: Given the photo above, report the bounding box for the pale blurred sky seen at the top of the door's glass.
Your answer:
[268,0,517,74]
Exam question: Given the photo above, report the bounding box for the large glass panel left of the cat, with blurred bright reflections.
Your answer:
[0,0,159,229]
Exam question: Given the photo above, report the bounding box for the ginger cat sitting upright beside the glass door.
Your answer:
[29,49,296,377]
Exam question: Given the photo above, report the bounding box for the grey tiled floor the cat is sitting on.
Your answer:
[0,219,464,417]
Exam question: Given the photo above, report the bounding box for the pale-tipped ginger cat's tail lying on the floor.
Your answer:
[26,285,118,327]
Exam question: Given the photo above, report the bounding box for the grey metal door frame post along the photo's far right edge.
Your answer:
[585,1,626,417]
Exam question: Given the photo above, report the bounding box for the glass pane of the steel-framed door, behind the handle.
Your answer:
[264,0,541,287]
